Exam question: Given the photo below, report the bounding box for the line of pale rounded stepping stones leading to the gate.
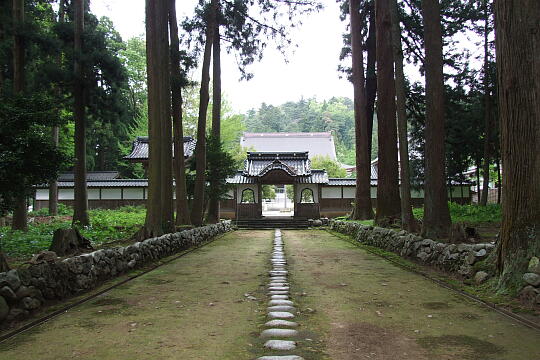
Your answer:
[258,229,303,360]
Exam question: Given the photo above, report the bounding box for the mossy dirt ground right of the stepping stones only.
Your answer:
[283,230,540,360]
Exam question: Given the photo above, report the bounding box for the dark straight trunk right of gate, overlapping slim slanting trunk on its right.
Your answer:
[375,0,401,225]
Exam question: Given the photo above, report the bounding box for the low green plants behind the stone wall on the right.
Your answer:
[413,202,502,224]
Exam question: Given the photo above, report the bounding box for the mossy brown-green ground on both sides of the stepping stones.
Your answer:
[0,230,540,360]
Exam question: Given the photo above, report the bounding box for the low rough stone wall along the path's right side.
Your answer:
[330,220,495,281]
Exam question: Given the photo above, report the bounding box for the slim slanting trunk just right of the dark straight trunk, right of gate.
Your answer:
[390,0,417,232]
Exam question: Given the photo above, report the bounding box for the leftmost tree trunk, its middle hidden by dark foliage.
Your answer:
[11,0,28,231]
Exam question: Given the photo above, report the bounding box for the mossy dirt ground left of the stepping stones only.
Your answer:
[0,231,273,360]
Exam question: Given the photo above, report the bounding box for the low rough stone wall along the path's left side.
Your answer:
[0,220,232,325]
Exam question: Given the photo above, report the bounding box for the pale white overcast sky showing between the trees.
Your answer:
[91,0,353,112]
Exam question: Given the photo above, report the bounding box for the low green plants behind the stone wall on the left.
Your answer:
[0,206,146,259]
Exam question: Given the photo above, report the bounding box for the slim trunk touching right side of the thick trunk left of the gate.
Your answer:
[169,0,191,225]
